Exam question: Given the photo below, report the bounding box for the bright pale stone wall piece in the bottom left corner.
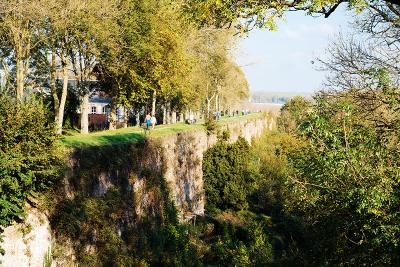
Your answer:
[0,208,51,267]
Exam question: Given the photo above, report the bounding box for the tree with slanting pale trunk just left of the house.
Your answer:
[31,0,89,134]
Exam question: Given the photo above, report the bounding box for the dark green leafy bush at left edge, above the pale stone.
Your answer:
[0,95,63,249]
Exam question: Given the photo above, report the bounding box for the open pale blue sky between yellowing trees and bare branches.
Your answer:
[236,7,352,94]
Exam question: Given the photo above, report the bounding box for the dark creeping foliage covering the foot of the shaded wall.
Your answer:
[51,184,202,266]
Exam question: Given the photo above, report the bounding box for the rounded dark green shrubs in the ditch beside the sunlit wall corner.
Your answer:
[203,132,302,266]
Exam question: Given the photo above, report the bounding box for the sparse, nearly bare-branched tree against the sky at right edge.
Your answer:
[320,16,400,135]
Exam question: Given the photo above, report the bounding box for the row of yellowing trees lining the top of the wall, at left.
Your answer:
[0,0,248,134]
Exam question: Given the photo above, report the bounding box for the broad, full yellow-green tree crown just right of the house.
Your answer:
[100,0,197,126]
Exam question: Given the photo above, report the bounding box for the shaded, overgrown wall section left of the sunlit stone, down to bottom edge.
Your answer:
[50,139,202,266]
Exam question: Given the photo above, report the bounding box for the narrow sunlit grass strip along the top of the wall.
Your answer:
[61,113,263,148]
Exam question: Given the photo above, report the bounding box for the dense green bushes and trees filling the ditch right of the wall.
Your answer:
[203,89,400,266]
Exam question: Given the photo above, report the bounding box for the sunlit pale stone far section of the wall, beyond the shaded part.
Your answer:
[162,116,274,221]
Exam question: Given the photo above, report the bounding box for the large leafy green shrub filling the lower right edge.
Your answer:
[289,90,400,265]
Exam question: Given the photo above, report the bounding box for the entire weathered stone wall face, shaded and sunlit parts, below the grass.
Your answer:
[0,116,274,266]
